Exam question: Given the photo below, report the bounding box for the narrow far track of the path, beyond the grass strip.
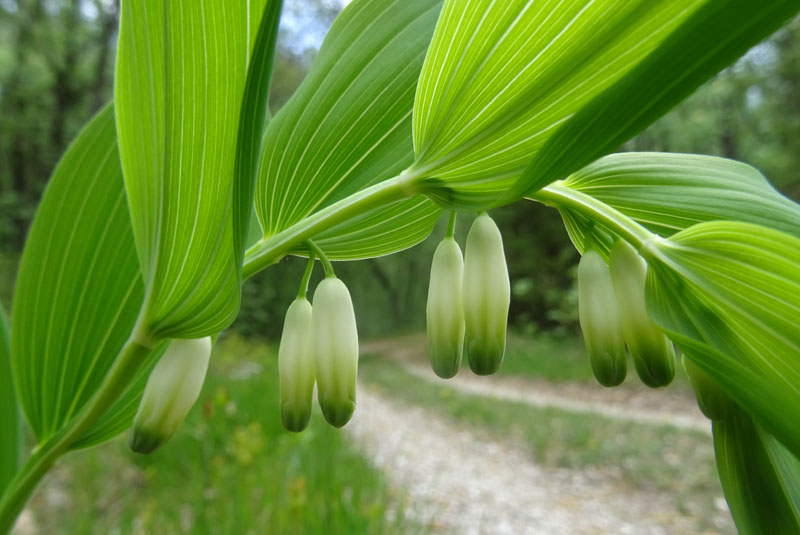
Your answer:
[362,335,711,434]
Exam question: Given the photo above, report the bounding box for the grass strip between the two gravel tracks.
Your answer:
[359,358,722,530]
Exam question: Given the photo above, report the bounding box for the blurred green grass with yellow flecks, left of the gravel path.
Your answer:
[28,339,420,535]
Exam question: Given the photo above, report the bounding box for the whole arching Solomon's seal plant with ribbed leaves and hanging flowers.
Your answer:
[0,0,800,533]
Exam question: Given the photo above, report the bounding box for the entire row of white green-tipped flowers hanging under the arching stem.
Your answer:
[130,216,708,446]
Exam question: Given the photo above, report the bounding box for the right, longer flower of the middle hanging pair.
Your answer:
[462,213,511,375]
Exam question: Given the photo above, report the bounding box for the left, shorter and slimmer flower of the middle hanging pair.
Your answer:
[425,238,464,379]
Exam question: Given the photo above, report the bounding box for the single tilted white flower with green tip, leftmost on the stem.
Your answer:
[130,337,211,453]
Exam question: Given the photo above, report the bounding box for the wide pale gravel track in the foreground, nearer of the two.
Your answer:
[345,384,720,535]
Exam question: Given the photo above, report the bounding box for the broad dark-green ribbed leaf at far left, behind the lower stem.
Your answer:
[12,105,159,445]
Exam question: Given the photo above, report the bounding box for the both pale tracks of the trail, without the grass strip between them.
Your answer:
[345,337,733,535]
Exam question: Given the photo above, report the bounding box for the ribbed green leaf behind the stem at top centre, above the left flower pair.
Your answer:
[256,0,441,259]
